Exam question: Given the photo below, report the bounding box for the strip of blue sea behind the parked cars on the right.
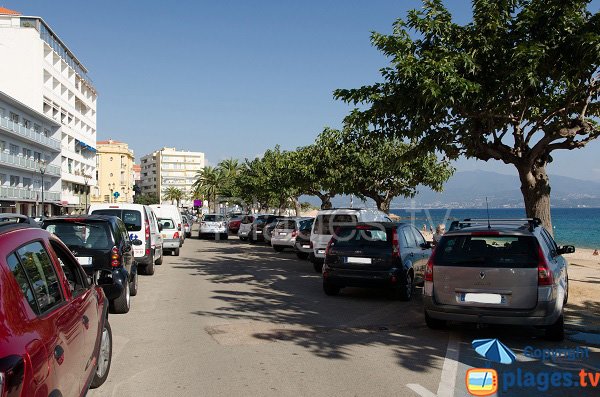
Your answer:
[390,208,600,249]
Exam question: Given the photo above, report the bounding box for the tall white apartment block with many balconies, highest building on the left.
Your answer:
[0,7,97,213]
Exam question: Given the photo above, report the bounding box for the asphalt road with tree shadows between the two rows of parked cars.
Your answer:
[89,232,600,397]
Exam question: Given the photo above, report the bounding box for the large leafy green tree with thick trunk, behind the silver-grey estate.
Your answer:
[334,0,600,230]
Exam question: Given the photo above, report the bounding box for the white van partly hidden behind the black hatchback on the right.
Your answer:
[309,208,392,272]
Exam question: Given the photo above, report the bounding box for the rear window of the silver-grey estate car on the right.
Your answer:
[435,235,538,268]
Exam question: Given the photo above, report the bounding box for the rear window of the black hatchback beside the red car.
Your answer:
[44,221,114,250]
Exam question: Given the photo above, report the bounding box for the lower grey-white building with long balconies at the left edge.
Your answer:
[0,91,61,216]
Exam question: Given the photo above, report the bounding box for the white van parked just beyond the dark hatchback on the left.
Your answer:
[88,203,163,274]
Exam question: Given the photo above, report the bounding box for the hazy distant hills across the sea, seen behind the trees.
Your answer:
[302,171,600,208]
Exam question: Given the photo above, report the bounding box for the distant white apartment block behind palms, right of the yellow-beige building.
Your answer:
[140,147,205,207]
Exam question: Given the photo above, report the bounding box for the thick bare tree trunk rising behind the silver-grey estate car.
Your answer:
[517,164,554,235]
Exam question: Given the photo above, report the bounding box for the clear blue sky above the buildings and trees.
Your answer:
[0,0,600,182]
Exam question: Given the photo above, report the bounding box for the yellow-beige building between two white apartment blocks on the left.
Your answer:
[91,139,135,203]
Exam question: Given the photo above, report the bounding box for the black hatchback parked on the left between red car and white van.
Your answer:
[42,215,141,313]
